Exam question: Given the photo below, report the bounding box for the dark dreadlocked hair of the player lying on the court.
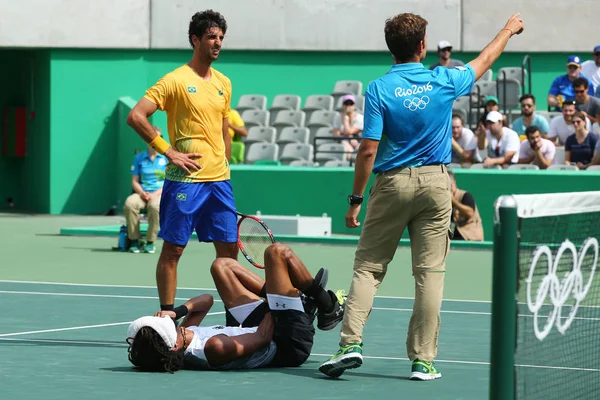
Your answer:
[126,326,185,374]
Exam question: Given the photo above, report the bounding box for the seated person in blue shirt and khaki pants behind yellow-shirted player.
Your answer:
[123,126,167,253]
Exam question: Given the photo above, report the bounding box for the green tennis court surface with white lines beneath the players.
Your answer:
[0,214,500,400]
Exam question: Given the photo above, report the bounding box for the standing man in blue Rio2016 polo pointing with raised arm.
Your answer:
[319,13,523,380]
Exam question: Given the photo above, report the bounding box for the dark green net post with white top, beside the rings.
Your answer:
[490,196,519,400]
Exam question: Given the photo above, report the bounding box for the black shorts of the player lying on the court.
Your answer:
[271,310,315,367]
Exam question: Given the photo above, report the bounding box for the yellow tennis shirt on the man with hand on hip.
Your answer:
[144,64,231,182]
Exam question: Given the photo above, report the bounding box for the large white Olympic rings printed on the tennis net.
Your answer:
[525,238,598,341]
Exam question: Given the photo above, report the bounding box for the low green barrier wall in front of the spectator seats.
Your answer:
[231,165,600,241]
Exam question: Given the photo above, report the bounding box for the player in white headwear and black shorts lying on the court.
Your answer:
[127,243,344,373]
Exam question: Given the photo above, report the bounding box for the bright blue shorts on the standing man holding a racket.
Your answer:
[158,180,237,246]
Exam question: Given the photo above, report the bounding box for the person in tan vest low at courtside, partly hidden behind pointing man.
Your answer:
[448,171,483,242]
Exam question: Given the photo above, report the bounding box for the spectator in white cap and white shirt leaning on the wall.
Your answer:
[478,111,521,168]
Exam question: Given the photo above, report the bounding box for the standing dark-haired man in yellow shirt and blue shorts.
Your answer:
[127,10,238,310]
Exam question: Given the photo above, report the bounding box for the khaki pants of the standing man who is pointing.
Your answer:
[341,166,452,361]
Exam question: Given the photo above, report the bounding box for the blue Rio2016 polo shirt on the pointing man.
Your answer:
[362,63,475,173]
